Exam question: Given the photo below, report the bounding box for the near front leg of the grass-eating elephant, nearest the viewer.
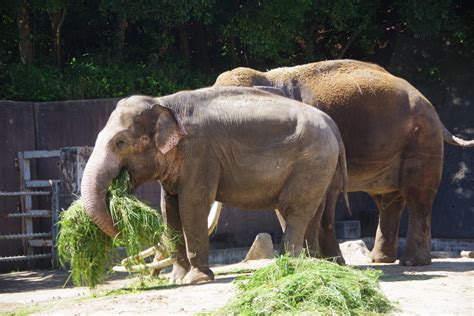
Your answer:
[179,194,214,284]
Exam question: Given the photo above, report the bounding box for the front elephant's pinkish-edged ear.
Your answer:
[153,104,187,155]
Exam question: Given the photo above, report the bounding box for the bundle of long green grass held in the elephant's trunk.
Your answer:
[58,170,174,288]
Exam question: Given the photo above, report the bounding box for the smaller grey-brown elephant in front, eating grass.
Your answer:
[82,87,347,283]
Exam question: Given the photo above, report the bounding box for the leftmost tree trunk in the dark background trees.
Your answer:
[17,0,34,64]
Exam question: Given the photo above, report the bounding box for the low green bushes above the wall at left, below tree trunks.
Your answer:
[0,56,211,101]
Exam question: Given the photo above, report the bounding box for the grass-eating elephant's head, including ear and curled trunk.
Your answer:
[81,96,186,237]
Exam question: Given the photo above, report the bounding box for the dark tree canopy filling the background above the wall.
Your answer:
[0,0,474,101]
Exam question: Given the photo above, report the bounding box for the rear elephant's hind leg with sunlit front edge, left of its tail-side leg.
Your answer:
[370,192,406,263]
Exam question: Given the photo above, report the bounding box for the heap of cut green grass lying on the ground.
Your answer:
[220,256,392,315]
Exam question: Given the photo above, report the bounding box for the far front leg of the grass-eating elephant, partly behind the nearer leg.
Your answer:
[161,189,190,284]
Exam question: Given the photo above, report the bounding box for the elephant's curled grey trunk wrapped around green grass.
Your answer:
[81,147,120,238]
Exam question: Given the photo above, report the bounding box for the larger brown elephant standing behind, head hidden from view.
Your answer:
[215,60,474,265]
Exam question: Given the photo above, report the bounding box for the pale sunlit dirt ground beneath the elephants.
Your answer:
[0,243,474,315]
